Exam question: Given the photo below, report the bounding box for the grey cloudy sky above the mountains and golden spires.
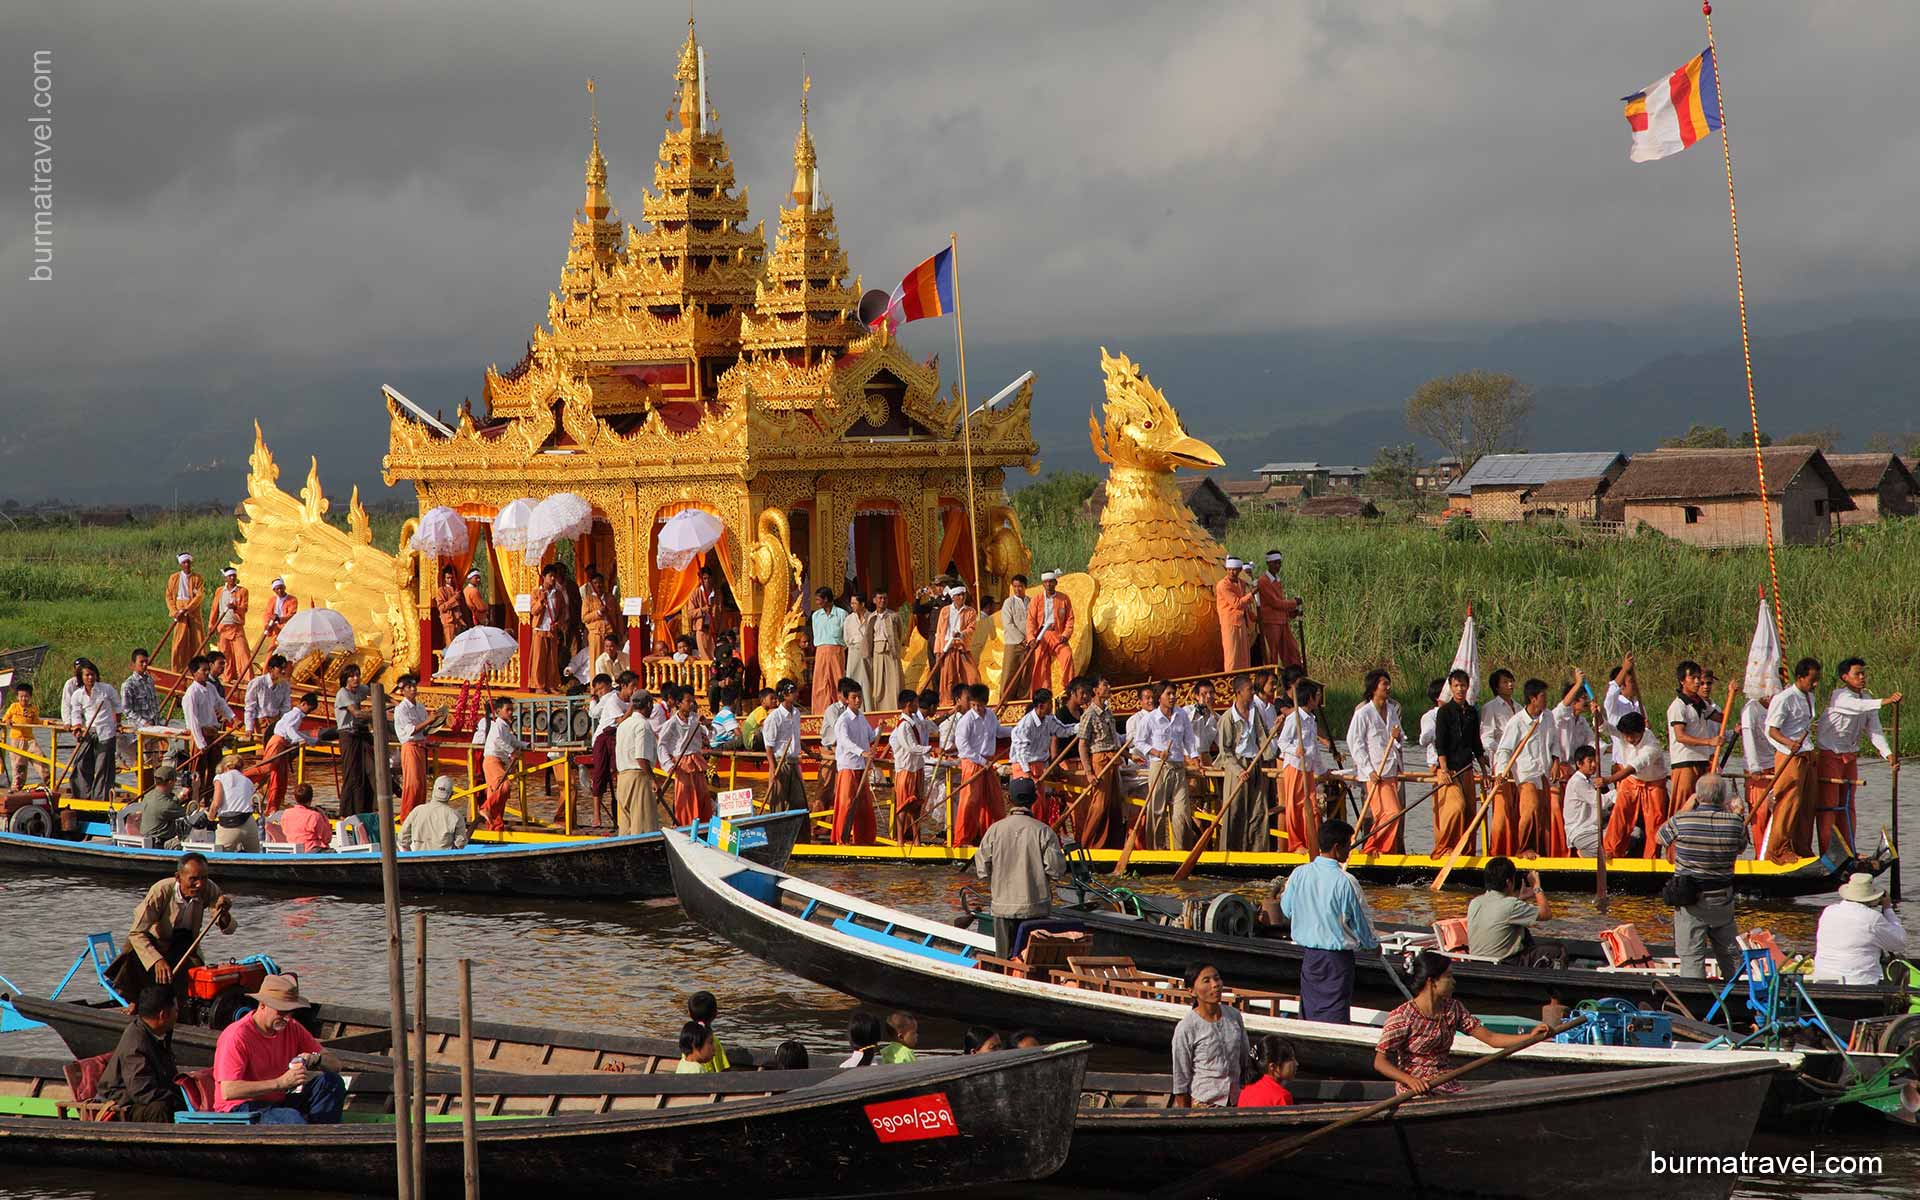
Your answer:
[0,0,1920,374]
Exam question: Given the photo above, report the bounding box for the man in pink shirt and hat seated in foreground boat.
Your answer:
[213,975,348,1125]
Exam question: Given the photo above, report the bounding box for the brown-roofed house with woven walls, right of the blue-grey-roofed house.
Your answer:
[1607,445,1855,545]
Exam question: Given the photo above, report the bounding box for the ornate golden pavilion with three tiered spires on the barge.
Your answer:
[360,21,1037,676]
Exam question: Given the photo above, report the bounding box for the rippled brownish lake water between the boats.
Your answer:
[0,762,1920,1200]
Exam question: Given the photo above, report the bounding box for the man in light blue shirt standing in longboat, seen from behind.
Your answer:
[1281,820,1380,1025]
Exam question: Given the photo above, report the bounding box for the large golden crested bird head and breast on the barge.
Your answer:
[1087,346,1227,680]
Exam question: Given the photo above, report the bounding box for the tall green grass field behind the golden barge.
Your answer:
[0,516,1920,747]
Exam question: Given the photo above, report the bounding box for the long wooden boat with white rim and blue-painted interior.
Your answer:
[668,833,1920,1104]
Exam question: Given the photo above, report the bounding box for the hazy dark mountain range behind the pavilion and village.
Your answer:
[0,307,1920,505]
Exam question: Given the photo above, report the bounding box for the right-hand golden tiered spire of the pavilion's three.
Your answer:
[741,77,866,367]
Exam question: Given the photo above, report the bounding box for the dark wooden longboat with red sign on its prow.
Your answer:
[0,1043,1087,1196]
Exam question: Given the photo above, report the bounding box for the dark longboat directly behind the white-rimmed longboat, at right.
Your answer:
[1062,910,1908,1037]
